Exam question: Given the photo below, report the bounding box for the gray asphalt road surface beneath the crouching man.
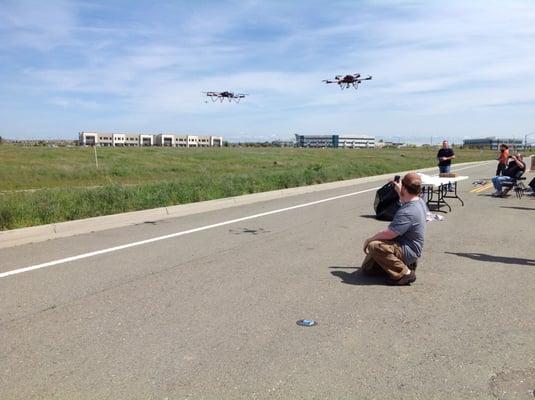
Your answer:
[0,164,535,399]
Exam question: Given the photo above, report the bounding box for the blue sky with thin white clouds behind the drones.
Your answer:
[0,0,535,143]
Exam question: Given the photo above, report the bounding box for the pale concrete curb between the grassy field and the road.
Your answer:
[0,161,494,249]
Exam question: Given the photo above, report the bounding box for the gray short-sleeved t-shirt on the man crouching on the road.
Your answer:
[388,199,427,264]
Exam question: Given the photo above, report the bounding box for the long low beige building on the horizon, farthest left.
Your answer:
[78,132,223,147]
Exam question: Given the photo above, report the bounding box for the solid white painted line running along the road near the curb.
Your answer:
[0,186,380,278]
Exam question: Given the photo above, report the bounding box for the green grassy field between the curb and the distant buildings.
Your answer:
[0,144,502,230]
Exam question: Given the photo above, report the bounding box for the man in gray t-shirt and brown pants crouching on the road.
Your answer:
[361,172,427,285]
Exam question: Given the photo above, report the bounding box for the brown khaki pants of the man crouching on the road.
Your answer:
[360,240,409,280]
